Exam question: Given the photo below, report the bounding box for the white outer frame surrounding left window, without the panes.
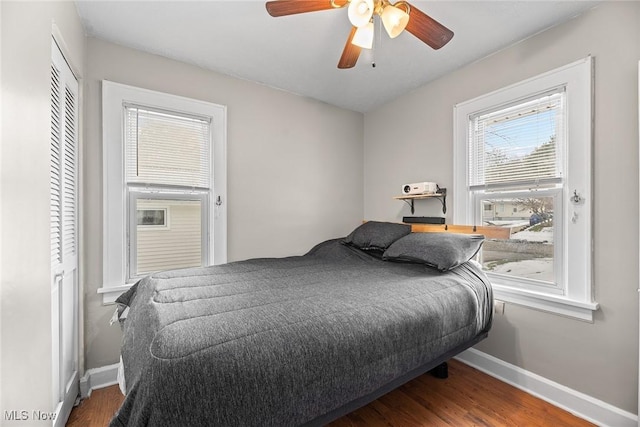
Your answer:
[98,80,227,304]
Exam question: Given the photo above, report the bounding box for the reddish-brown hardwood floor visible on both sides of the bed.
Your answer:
[67,360,593,427]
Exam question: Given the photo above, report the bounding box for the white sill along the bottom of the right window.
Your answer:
[492,284,600,323]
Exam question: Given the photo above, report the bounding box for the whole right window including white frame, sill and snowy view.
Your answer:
[454,57,597,321]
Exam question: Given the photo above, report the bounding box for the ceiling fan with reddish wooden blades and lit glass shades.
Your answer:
[266,0,453,68]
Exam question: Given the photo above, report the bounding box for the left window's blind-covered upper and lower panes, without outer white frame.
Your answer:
[123,104,212,281]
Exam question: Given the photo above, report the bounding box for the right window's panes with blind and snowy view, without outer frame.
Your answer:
[468,87,566,293]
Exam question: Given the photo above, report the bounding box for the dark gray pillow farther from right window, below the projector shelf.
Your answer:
[344,221,411,252]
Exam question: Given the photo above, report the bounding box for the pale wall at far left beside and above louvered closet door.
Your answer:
[0,2,85,425]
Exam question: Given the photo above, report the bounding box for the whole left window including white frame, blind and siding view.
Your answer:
[100,81,226,302]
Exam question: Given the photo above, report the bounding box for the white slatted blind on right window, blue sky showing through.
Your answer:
[469,88,565,189]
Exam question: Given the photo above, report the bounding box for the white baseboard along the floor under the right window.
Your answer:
[456,348,638,427]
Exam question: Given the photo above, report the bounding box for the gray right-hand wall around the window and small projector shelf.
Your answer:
[364,2,640,413]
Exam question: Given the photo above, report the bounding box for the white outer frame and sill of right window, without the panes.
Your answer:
[453,56,598,322]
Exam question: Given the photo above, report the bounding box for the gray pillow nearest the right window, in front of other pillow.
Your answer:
[382,233,484,271]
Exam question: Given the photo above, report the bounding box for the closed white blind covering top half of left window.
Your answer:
[125,106,211,188]
